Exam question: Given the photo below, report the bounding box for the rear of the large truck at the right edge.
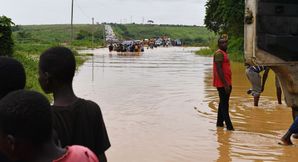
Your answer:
[244,0,298,118]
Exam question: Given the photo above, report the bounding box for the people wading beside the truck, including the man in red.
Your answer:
[213,35,298,145]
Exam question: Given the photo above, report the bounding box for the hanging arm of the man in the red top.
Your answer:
[214,53,231,94]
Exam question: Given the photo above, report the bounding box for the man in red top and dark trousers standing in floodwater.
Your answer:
[213,37,234,130]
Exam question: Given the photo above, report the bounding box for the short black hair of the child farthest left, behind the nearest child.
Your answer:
[0,56,26,99]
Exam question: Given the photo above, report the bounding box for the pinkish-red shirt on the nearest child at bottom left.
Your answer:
[53,145,99,162]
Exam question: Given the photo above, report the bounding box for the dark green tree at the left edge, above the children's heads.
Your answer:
[0,16,14,56]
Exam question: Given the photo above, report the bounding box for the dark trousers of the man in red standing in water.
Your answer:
[216,86,234,130]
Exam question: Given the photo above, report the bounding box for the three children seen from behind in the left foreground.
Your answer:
[0,47,111,162]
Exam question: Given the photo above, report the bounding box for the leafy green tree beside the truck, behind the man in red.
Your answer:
[197,0,245,62]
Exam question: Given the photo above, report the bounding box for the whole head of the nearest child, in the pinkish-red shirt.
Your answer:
[0,90,53,160]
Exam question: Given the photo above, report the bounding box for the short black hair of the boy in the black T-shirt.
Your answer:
[39,47,76,83]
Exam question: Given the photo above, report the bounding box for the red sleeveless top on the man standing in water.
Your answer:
[213,49,232,87]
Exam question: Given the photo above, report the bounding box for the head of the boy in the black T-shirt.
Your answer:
[39,47,76,93]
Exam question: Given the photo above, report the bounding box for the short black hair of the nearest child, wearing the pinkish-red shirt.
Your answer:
[0,90,53,145]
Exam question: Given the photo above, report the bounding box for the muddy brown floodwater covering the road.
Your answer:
[74,47,298,162]
